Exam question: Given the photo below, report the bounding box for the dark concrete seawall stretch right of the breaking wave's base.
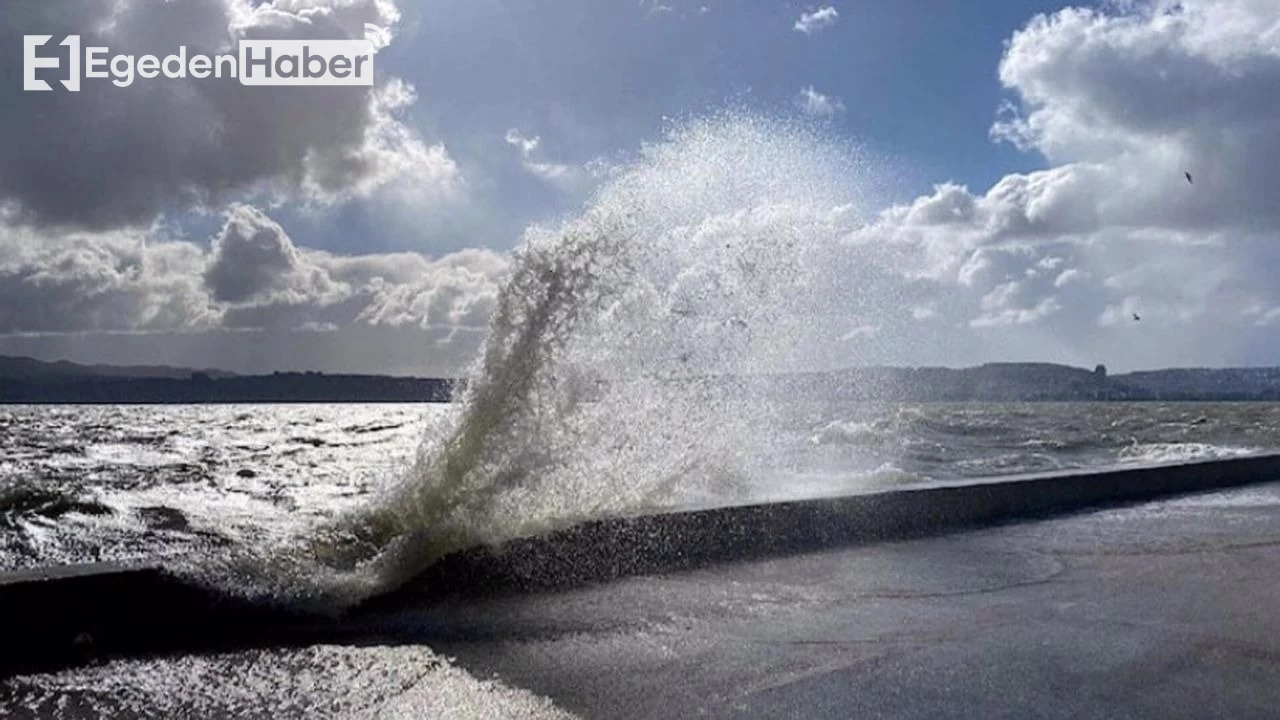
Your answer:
[381,455,1280,606]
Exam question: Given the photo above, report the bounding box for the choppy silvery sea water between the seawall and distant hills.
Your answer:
[0,404,1280,569]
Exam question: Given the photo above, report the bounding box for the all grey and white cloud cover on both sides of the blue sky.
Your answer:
[0,0,1280,374]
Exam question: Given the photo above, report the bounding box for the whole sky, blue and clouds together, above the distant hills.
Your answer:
[0,0,1280,375]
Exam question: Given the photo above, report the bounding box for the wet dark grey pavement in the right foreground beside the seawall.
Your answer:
[401,484,1280,717]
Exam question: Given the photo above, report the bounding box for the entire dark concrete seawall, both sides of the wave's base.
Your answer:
[0,455,1280,675]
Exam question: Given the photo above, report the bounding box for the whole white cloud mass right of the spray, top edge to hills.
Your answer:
[849,0,1280,364]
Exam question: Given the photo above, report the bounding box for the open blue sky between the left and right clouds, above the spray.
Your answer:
[282,0,1061,251]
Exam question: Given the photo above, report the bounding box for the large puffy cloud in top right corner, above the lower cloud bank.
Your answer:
[992,0,1280,231]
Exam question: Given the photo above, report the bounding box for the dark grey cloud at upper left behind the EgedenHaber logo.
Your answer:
[0,0,460,229]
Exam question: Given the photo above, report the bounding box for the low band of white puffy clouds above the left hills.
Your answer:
[0,205,508,340]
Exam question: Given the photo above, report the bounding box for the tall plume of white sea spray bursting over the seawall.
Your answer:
[235,115,885,601]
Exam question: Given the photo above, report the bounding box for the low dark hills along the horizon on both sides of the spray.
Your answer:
[0,356,1280,404]
